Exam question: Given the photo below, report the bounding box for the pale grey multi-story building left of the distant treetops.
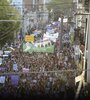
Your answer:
[23,0,48,33]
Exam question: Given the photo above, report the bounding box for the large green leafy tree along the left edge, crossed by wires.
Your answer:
[0,0,20,46]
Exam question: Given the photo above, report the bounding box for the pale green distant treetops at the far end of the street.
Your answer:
[47,0,73,20]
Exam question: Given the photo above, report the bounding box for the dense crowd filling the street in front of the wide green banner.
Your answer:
[0,21,85,99]
